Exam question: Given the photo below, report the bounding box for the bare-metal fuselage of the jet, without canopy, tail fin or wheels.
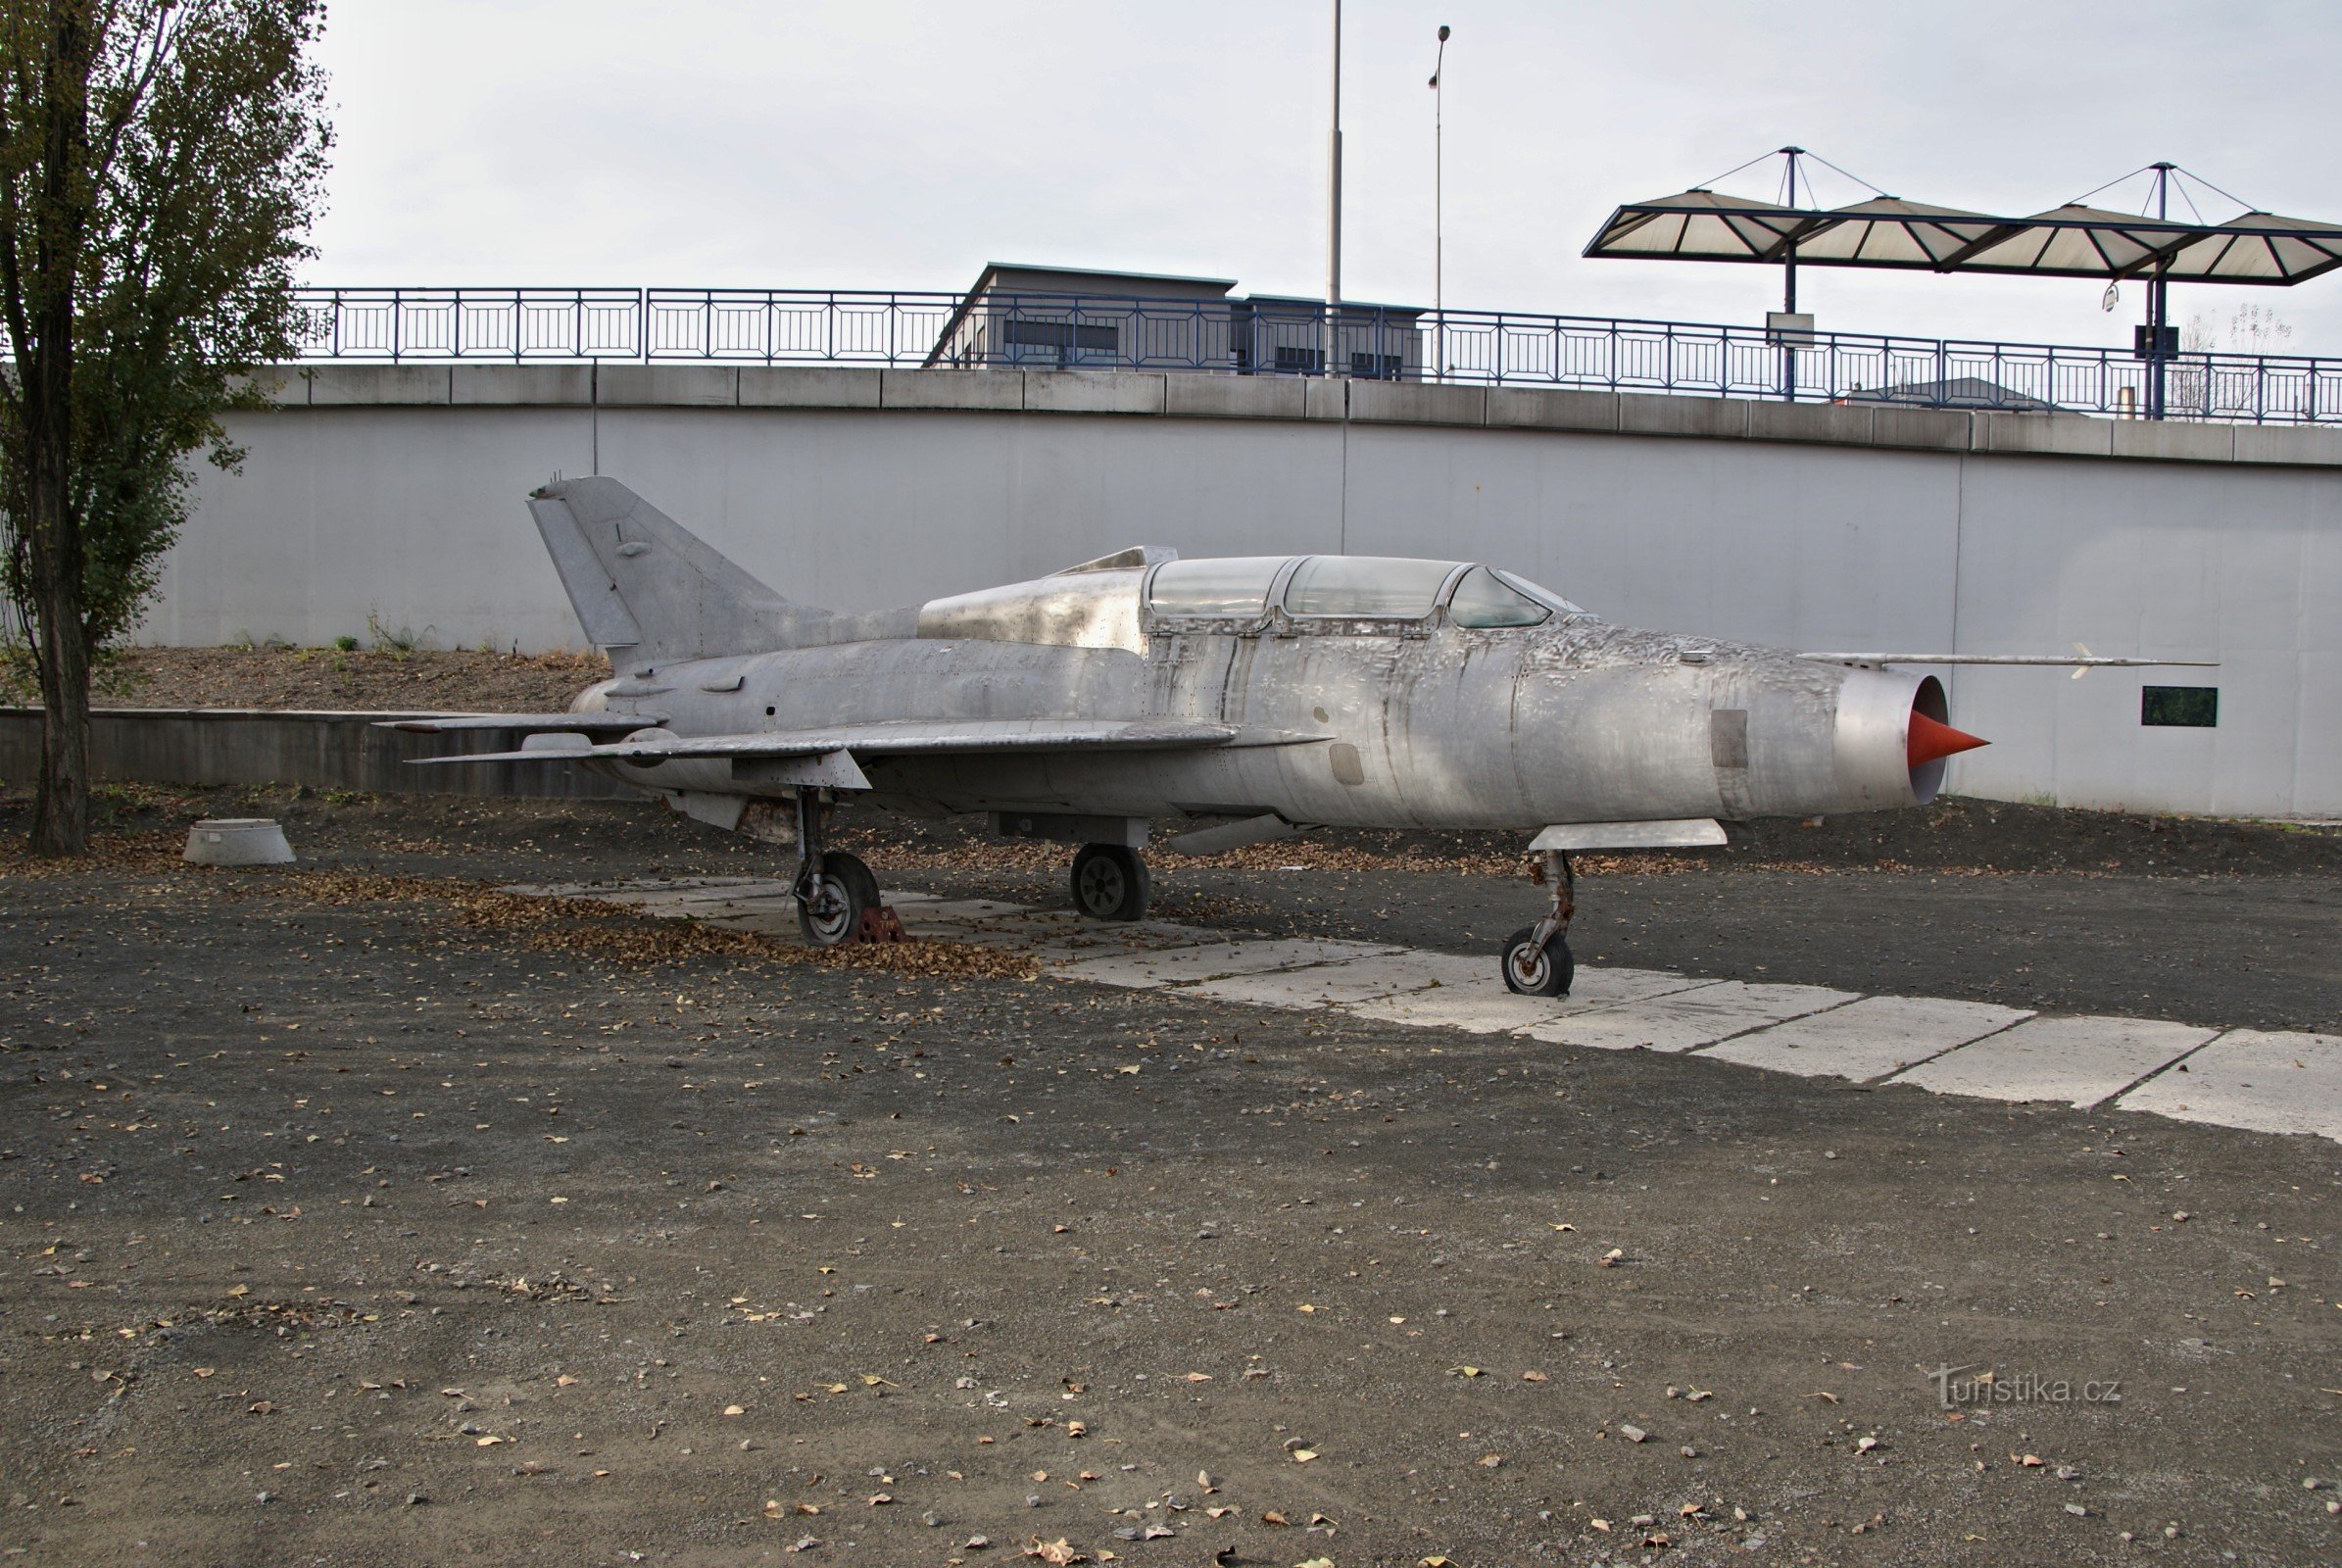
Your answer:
[574,567,1944,830]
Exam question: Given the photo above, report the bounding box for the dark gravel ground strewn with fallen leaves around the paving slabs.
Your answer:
[0,792,2342,1568]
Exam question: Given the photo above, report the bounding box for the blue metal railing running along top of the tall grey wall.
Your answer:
[300,288,2342,424]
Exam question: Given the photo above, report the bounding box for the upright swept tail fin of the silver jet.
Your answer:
[529,476,831,665]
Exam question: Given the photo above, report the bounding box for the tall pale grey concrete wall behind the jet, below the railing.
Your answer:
[143,366,2342,815]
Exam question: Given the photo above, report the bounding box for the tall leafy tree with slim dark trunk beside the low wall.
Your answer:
[0,0,332,854]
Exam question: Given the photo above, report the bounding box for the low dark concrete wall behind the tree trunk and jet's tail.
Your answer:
[0,708,642,800]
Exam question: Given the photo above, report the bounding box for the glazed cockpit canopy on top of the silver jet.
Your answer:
[1147,556,1586,630]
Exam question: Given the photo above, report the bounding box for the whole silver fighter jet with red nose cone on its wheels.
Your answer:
[401,478,2201,996]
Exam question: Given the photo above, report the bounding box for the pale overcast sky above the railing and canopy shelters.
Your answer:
[309,0,2342,354]
